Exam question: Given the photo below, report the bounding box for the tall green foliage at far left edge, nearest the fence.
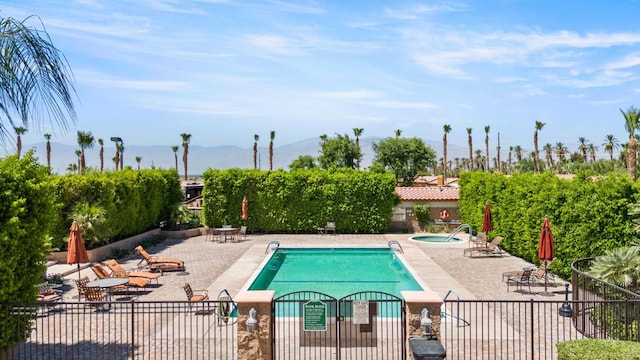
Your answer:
[0,152,56,349]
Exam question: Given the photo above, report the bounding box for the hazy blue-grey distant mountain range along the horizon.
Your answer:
[23,137,470,174]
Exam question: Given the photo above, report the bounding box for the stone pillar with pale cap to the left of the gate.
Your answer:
[234,290,275,360]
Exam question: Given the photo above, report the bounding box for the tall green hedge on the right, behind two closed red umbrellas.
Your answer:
[459,172,639,279]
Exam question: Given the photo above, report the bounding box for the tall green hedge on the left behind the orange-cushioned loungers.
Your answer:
[51,169,184,248]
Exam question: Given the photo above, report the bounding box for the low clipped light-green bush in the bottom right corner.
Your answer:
[556,339,640,360]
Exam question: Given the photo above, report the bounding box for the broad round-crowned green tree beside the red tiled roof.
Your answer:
[372,137,437,186]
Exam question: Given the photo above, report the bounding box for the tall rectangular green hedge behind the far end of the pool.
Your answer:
[202,169,398,234]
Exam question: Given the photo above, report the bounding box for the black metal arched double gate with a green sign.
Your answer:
[271,291,406,360]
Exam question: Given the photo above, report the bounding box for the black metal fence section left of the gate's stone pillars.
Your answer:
[0,301,237,360]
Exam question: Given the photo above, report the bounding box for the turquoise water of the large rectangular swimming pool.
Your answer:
[249,248,423,298]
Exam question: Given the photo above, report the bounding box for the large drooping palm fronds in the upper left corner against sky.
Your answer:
[0,16,76,136]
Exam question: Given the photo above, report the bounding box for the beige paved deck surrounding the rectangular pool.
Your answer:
[47,234,565,301]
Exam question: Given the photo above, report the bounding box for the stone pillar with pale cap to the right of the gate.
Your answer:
[400,290,444,359]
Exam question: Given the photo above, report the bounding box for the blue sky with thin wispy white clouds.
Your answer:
[0,0,640,152]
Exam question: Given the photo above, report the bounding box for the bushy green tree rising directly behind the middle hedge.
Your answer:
[318,134,362,169]
